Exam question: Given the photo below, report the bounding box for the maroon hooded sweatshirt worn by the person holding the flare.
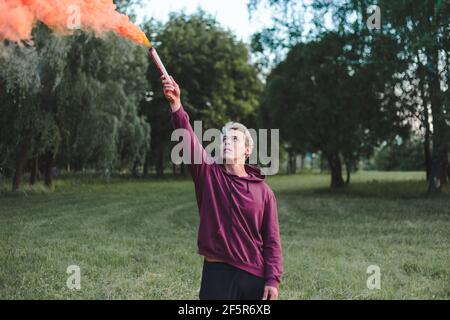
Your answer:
[171,107,283,287]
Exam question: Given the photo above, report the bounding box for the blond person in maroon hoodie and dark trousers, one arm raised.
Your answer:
[161,76,282,300]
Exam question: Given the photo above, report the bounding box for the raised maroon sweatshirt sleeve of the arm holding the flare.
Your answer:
[171,106,213,185]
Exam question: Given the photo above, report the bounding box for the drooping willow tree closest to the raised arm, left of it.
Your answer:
[55,33,150,178]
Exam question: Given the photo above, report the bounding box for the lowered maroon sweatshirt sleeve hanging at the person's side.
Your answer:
[262,190,283,287]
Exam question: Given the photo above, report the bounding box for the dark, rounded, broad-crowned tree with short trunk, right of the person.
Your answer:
[263,33,407,188]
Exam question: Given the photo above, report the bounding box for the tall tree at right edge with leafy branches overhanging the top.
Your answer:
[249,0,450,193]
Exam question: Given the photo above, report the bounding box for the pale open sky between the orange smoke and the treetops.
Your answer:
[137,0,271,42]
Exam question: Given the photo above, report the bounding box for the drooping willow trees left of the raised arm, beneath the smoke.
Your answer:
[0,25,150,190]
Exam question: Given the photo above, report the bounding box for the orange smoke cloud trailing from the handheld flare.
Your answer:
[0,0,151,48]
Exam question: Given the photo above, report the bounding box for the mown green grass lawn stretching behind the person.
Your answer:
[0,172,450,299]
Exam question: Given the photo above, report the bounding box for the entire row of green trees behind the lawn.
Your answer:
[0,0,450,193]
